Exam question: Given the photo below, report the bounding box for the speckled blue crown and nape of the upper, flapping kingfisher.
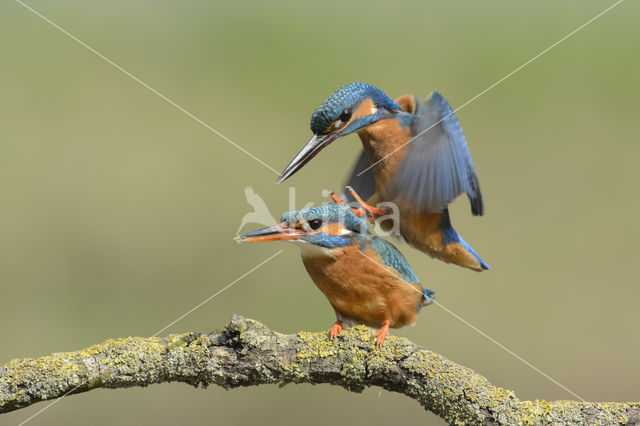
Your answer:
[311,83,402,134]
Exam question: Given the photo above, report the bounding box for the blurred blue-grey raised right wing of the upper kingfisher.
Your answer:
[393,92,484,216]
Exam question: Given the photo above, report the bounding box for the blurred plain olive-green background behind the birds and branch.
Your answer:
[0,0,640,426]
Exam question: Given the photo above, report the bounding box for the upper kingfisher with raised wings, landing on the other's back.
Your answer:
[277,83,489,271]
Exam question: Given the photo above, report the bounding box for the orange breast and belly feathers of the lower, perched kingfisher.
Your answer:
[302,245,423,328]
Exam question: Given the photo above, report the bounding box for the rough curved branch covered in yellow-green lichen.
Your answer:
[0,315,640,424]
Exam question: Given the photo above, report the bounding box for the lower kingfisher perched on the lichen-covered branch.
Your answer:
[235,203,435,346]
